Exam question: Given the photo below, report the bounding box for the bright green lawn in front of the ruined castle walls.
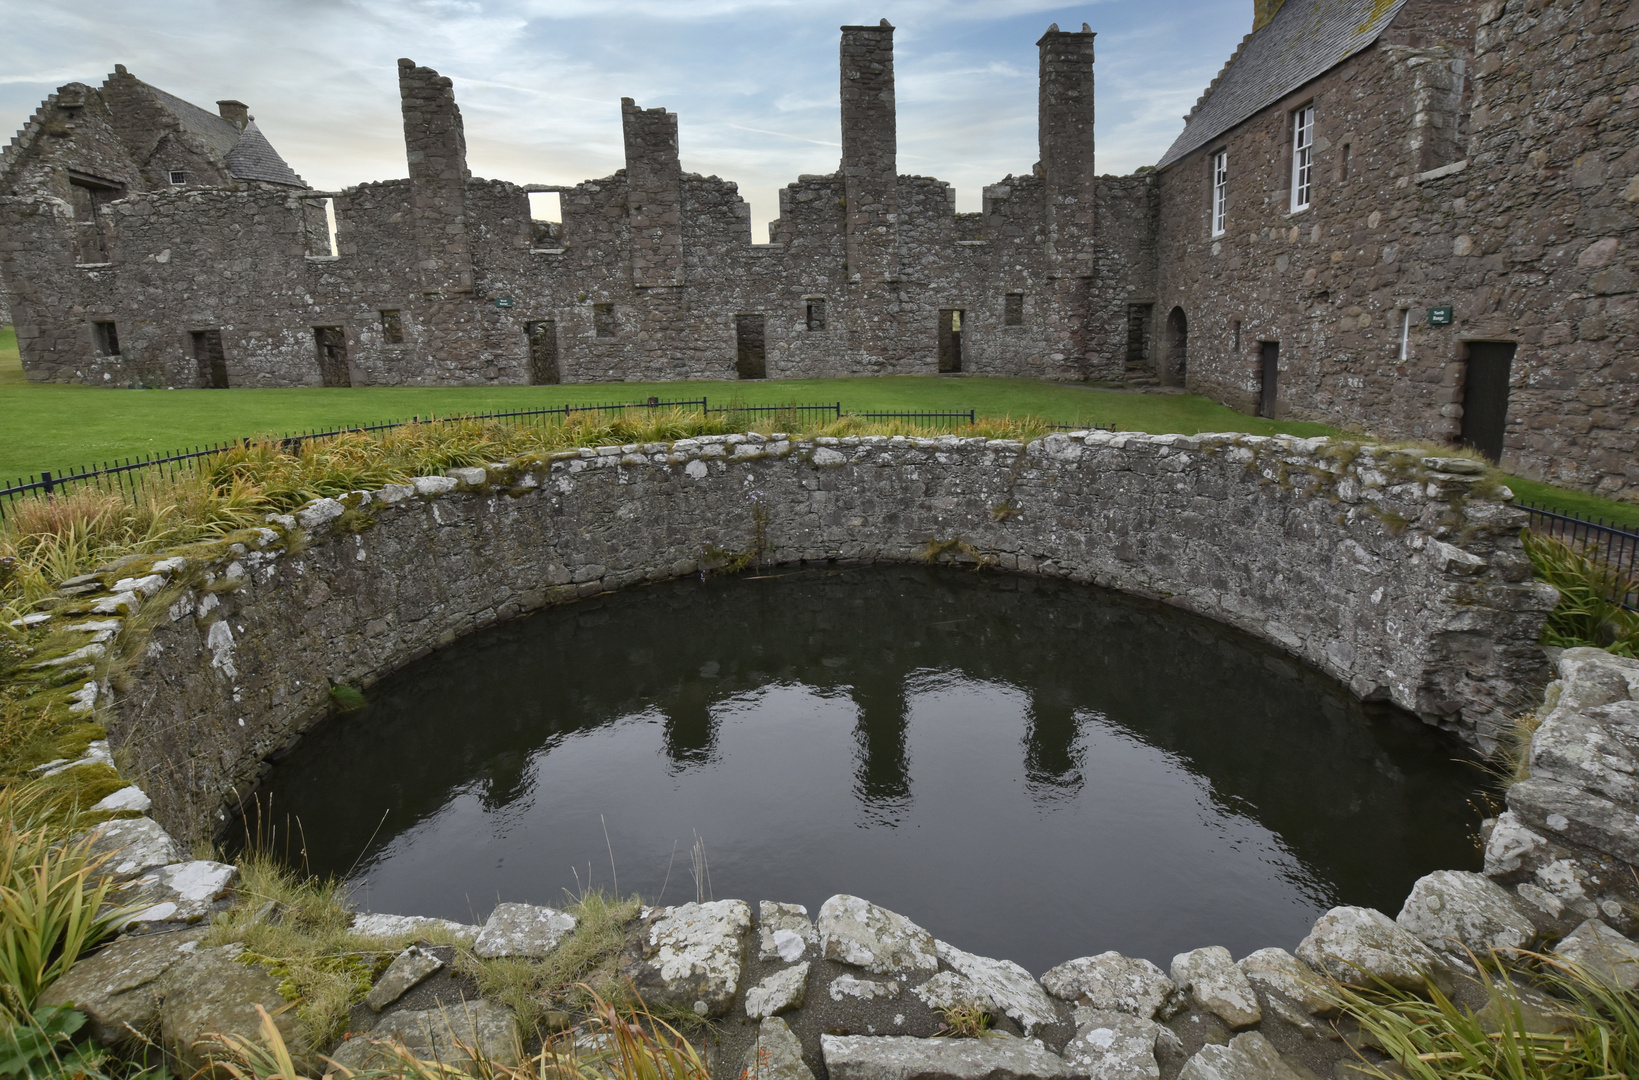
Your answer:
[0,326,1639,528]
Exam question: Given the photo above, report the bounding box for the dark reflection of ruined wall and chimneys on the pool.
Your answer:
[245,567,1488,895]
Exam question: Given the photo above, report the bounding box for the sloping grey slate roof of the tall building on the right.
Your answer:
[1155,0,1406,169]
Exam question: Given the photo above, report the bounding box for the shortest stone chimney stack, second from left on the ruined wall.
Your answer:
[620,97,683,288]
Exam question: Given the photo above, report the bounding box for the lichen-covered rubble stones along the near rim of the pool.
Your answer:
[43,649,1639,1080]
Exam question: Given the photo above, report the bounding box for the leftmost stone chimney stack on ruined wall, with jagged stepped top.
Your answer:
[398,61,472,293]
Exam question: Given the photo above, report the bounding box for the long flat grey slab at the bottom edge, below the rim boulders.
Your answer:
[820,1032,1078,1080]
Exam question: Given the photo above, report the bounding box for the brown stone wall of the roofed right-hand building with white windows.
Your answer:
[1155,0,1639,495]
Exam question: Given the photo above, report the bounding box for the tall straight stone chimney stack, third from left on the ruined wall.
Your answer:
[842,20,900,284]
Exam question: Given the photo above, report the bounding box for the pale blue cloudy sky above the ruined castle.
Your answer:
[0,0,1252,231]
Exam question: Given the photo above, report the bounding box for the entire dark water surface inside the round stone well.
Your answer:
[252,567,1480,973]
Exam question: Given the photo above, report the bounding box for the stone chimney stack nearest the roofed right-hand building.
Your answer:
[1036,23,1098,277]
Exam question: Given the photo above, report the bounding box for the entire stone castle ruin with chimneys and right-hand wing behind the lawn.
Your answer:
[0,0,1639,495]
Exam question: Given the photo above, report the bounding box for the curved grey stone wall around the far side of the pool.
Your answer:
[35,431,1555,837]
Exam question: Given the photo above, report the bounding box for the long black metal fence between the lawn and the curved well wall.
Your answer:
[0,397,1088,520]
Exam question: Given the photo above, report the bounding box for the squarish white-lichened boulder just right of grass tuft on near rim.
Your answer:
[621,900,751,1016]
